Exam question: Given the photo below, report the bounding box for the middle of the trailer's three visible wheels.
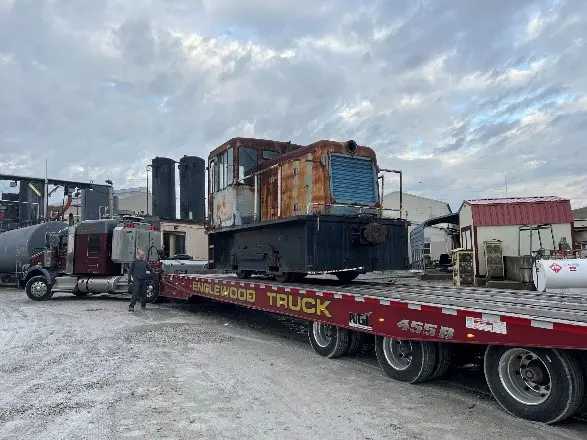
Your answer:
[375,336,438,383]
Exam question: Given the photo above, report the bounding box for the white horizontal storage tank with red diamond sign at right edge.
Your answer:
[533,258,587,292]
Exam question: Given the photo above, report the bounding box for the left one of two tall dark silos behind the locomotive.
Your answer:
[151,157,176,219]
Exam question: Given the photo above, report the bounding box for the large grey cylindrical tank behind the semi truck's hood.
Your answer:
[0,222,67,273]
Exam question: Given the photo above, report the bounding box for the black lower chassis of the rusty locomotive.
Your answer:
[208,215,408,274]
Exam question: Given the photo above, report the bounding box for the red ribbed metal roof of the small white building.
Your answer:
[461,196,574,226]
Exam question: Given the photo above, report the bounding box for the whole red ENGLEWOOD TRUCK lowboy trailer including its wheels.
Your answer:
[161,273,587,423]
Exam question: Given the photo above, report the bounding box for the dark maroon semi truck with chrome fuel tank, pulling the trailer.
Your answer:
[19,216,161,302]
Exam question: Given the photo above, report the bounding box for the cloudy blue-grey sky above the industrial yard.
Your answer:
[0,0,587,213]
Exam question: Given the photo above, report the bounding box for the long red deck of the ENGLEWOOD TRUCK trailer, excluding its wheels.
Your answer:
[164,275,587,349]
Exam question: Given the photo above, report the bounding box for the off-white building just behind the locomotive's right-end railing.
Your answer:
[383,191,452,263]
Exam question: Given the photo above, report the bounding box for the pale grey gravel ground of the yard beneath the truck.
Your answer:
[0,289,587,440]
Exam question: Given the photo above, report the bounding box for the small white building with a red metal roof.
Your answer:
[459,197,573,277]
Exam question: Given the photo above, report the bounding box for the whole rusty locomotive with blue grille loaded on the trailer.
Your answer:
[207,138,408,282]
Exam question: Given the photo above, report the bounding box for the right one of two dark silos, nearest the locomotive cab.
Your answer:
[179,156,206,223]
